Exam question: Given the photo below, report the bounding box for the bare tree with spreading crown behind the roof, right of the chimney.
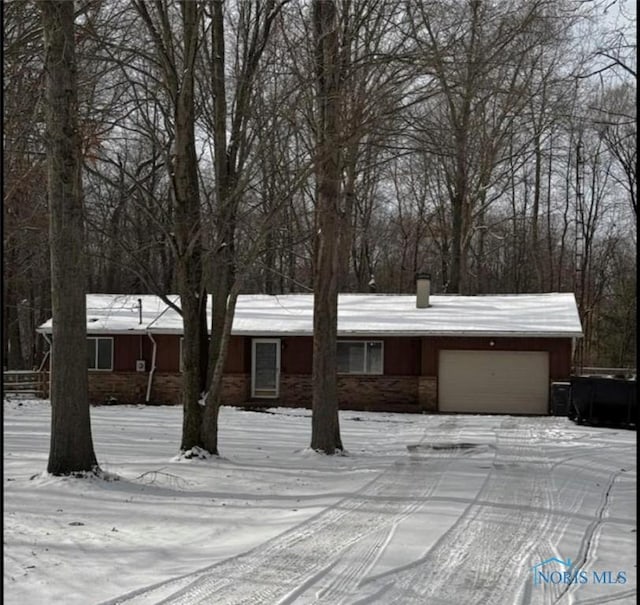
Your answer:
[409,0,584,292]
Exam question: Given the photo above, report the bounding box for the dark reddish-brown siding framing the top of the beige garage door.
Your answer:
[422,337,571,380]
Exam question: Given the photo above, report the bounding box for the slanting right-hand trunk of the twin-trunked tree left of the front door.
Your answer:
[201,0,288,454]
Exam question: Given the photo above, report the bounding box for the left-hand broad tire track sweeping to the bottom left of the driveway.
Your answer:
[104,421,464,605]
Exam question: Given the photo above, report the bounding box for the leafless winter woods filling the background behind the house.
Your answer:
[3,0,637,458]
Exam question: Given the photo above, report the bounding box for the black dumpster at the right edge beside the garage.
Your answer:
[568,376,637,428]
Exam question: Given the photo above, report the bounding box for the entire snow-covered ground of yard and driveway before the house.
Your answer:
[4,400,637,605]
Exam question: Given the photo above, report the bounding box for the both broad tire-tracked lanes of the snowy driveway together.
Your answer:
[104,418,635,605]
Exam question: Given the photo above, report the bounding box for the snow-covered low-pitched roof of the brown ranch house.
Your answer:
[39,293,582,338]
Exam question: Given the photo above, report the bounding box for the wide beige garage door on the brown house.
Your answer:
[438,351,549,414]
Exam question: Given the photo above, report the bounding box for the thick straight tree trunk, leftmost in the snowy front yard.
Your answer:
[38,0,99,475]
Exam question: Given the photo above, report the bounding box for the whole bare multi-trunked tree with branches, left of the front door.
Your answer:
[74,0,286,453]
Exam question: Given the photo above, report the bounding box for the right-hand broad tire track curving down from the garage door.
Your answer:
[362,419,564,605]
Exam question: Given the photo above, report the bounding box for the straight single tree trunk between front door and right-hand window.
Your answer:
[311,0,342,454]
